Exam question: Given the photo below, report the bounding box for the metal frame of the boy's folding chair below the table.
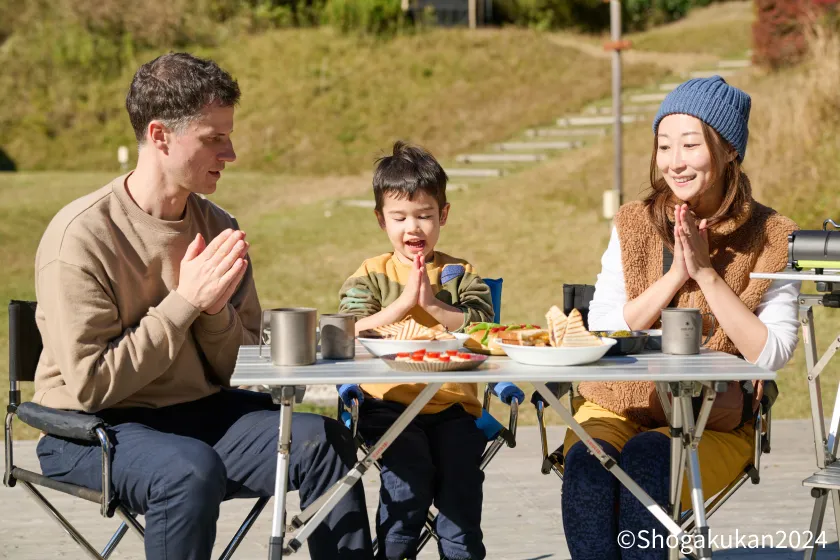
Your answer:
[336,383,519,555]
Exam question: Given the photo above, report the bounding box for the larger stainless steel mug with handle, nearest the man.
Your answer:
[259,307,318,366]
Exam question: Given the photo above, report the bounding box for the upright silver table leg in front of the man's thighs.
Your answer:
[268,387,295,560]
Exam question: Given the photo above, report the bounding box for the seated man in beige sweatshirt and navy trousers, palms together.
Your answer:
[34,53,372,560]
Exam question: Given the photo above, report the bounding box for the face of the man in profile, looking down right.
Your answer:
[163,105,236,195]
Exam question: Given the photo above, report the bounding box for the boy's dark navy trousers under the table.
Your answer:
[359,397,487,560]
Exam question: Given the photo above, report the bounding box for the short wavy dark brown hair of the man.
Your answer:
[125,53,240,144]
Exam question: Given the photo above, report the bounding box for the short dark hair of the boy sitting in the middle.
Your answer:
[373,140,448,213]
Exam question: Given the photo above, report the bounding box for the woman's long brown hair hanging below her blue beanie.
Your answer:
[644,121,752,250]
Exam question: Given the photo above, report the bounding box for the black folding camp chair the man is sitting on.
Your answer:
[3,300,268,560]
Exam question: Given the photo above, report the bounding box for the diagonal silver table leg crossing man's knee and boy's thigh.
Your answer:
[280,383,443,560]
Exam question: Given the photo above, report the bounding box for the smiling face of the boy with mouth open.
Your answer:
[376,191,449,264]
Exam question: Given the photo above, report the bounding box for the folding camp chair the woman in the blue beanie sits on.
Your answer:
[531,284,778,532]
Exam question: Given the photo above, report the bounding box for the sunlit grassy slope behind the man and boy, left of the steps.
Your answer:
[0,25,663,175]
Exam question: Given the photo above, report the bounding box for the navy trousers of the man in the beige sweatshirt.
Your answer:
[38,389,373,560]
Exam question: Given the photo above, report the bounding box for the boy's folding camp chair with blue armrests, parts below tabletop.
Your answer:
[338,383,519,554]
